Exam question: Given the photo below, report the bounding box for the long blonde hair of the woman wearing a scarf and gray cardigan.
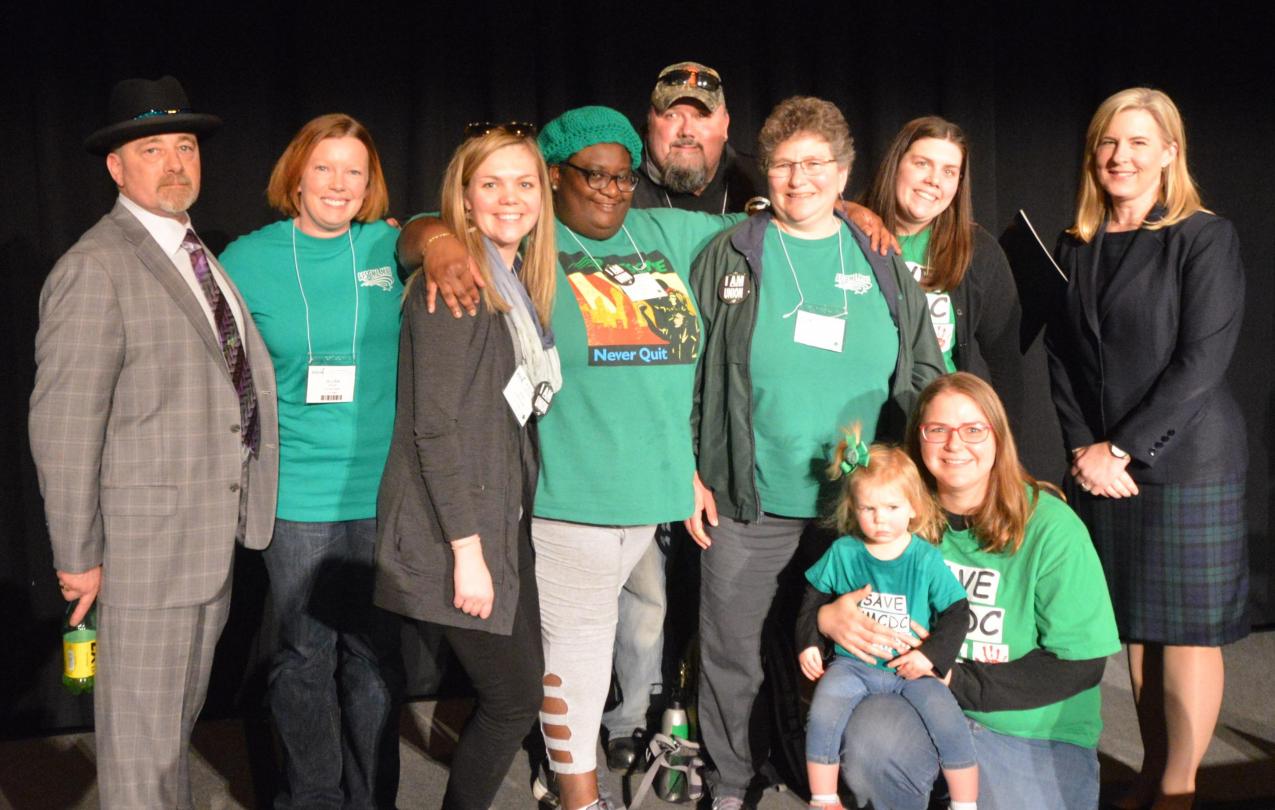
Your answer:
[417,129,557,327]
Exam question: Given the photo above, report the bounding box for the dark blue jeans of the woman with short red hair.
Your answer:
[264,519,403,810]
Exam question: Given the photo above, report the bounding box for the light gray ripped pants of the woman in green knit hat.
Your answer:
[532,518,655,773]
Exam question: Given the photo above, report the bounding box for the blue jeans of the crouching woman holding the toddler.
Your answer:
[842,695,1098,810]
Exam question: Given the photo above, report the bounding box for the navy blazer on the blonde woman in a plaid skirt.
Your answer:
[1046,208,1248,483]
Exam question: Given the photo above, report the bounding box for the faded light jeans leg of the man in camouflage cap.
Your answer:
[602,529,667,740]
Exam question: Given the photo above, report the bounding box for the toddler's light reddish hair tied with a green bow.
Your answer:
[825,423,942,545]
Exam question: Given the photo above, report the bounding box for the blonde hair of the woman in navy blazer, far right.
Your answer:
[1067,87,1207,242]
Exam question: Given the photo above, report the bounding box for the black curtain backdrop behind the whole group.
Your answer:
[0,0,1275,736]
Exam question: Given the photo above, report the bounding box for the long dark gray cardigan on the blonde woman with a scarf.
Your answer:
[374,283,538,635]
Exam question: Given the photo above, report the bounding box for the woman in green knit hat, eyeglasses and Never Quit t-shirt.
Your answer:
[399,107,742,810]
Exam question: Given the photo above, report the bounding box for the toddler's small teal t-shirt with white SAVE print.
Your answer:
[806,534,965,672]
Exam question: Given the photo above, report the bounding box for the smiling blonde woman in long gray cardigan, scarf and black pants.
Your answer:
[376,128,562,810]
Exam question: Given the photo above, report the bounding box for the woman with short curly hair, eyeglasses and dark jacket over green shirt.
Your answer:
[687,97,944,810]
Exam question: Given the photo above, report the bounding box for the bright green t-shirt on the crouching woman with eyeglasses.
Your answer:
[940,492,1119,747]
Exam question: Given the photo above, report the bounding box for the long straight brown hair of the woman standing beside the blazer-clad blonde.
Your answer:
[863,115,974,291]
